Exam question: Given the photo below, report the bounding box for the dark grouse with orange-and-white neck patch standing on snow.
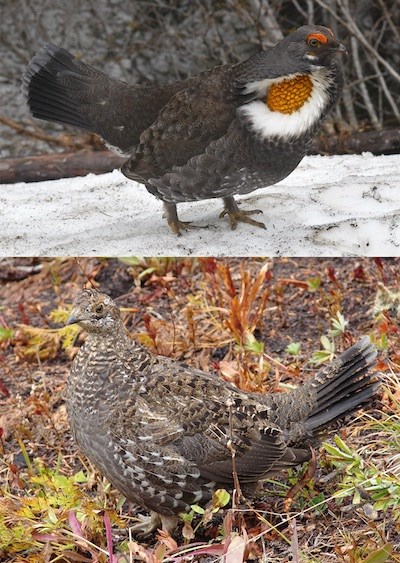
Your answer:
[22,25,346,234]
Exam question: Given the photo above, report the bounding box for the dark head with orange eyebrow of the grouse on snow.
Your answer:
[280,25,348,71]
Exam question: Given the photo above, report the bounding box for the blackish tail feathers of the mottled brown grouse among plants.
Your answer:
[305,336,379,432]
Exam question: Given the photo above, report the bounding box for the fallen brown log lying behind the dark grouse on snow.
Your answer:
[0,128,400,184]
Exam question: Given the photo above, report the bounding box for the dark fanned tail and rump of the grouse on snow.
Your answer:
[21,44,180,153]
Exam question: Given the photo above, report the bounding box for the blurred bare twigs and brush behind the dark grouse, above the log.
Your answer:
[0,0,400,157]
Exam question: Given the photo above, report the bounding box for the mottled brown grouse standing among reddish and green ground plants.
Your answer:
[67,289,378,532]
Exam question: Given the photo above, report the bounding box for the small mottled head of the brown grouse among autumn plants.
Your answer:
[66,289,121,334]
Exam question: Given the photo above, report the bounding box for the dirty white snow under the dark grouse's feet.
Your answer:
[0,153,400,256]
